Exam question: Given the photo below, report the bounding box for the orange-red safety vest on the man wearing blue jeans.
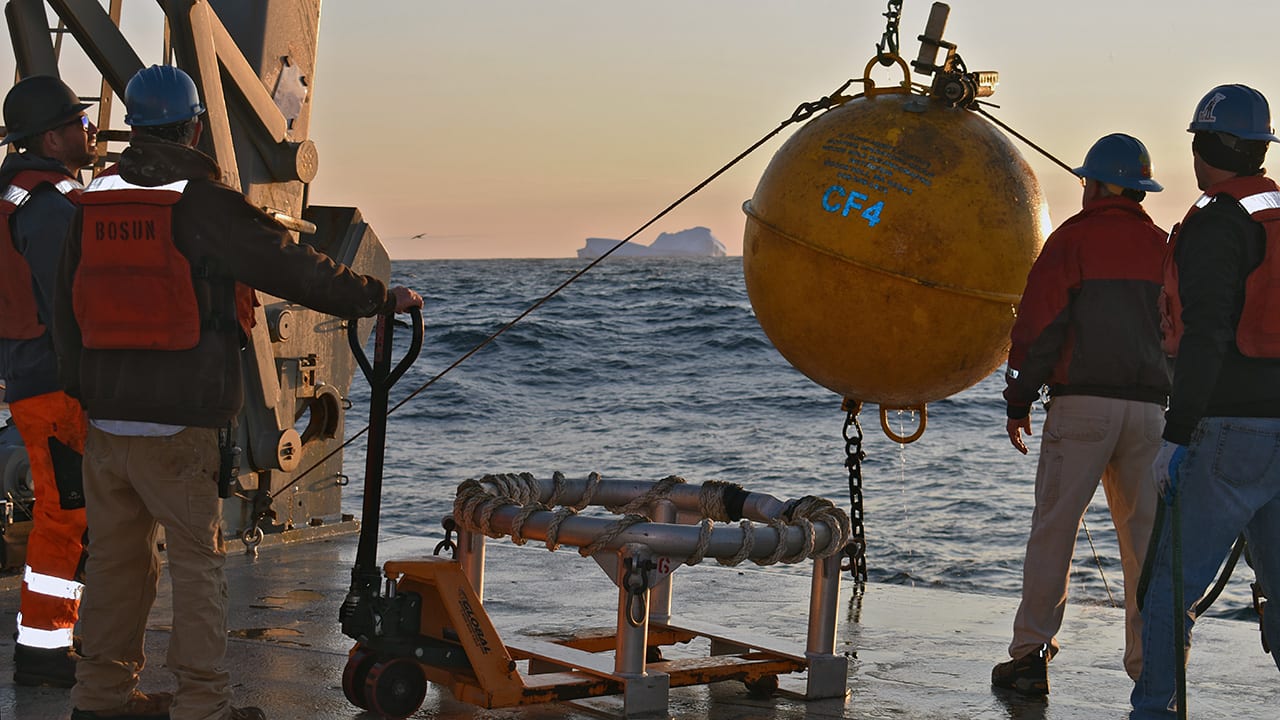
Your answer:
[1160,176,1280,359]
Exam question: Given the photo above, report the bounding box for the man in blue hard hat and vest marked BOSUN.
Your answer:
[54,65,422,720]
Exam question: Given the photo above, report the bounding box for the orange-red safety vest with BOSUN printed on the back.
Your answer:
[72,175,257,350]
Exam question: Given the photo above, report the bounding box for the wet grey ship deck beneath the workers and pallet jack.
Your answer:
[0,534,1280,720]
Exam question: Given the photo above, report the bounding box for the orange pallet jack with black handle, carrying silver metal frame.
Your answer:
[339,311,847,719]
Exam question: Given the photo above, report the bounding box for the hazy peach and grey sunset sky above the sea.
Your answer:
[0,0,1280,259]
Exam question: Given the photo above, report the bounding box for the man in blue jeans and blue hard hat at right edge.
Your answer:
[1130,85,1280,720]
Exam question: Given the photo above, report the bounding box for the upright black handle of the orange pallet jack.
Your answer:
[347,307,422,594]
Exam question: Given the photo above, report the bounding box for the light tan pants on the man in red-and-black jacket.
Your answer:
[1009,395,1165,679]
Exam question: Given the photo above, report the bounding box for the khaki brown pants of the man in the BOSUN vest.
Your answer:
[72,427,230,720]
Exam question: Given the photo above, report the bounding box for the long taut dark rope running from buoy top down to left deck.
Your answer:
[255,79,855,504]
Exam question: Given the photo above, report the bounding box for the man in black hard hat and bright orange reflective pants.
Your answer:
[0,76,97,688]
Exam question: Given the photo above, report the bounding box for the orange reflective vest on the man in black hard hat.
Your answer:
[0,170,83,340]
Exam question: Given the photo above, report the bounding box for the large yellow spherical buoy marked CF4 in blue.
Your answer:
[742,88,1048,416]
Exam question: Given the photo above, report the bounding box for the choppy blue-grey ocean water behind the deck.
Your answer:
[346,258,1253,618]
